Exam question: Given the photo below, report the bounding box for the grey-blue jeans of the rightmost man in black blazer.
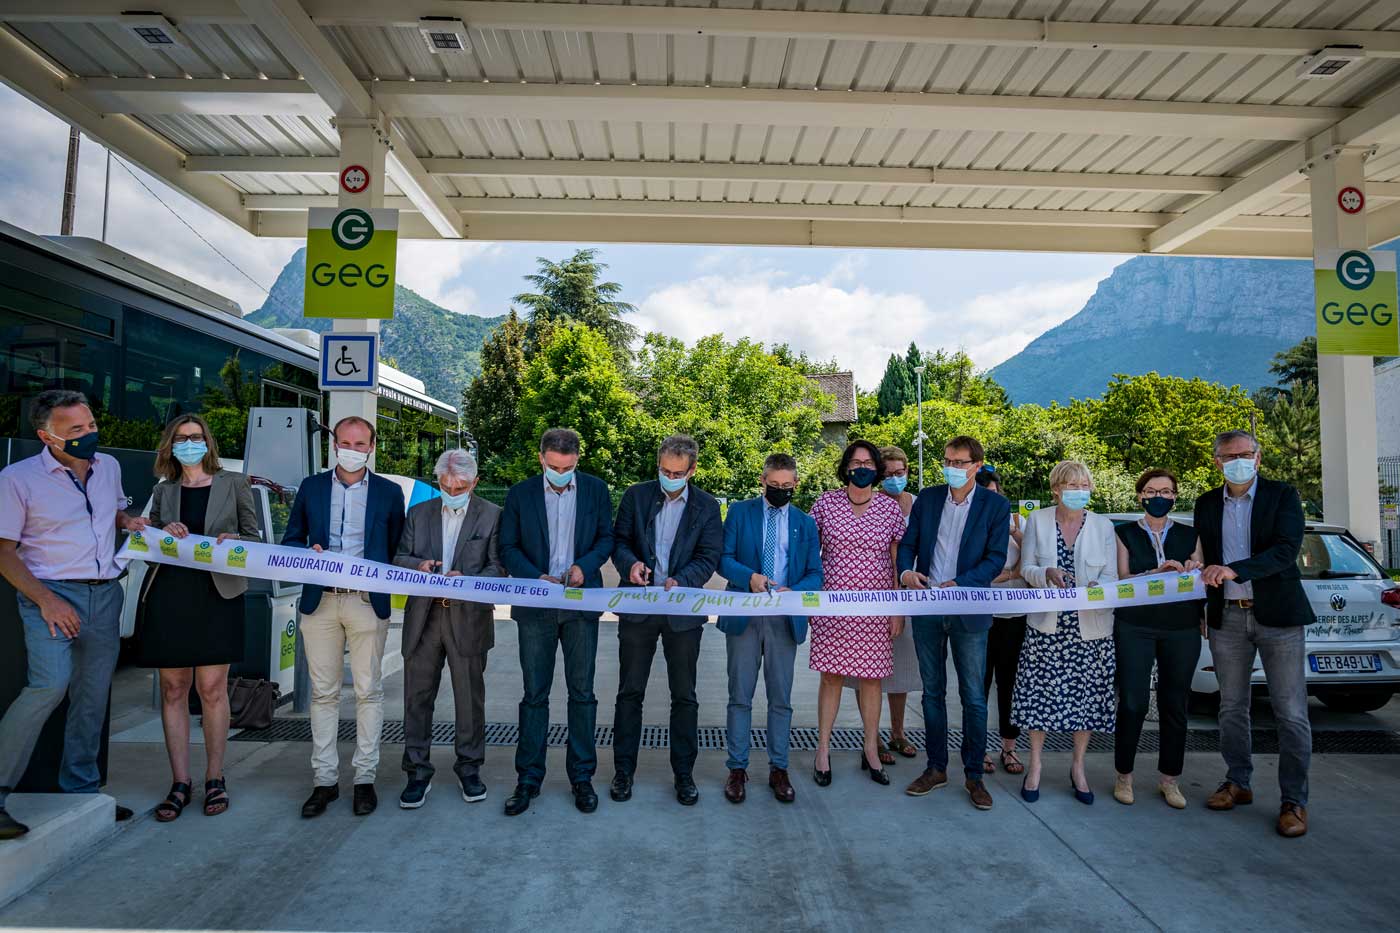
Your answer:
[1210,607,1312,807]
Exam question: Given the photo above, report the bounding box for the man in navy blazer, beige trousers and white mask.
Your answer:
[281,416,403,818]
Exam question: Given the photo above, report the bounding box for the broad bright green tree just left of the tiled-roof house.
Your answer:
[631,333,832,497]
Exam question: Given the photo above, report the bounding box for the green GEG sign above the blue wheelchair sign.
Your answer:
[302,207,399,318]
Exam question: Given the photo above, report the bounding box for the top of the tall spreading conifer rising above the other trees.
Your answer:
[514,249,637,366]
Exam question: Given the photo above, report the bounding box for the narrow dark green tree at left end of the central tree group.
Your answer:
[462,308,525,479]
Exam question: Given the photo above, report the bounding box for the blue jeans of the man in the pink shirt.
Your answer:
[0,580,122,807]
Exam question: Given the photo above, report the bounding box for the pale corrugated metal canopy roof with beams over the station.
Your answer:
[0,0,1400,256]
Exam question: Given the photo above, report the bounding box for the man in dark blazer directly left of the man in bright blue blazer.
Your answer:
[609,434,724,807]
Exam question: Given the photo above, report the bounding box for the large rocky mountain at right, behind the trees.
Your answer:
[991,244,1396,405]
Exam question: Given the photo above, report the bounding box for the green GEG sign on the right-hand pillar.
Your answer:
[1313,249,1400,356]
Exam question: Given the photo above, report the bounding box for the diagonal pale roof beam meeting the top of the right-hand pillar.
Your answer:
[1147,77,1400,252]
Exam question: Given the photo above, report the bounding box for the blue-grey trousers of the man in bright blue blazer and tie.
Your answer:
[724,615,797,770]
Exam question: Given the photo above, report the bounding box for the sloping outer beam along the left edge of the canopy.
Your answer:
[0,28,255,231]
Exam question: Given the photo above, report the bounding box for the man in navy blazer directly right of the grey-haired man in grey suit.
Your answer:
[500,427,613,817]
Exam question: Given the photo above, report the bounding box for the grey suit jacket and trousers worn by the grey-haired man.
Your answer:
[393,496,505,780]
